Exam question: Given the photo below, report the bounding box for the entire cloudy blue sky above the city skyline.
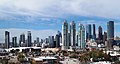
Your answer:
[0,0,120,42]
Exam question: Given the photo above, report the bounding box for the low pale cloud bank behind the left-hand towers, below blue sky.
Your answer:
[0,28,57,43]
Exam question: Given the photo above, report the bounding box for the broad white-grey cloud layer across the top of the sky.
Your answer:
[0,0,120,19]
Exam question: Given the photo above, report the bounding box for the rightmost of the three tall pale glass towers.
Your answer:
[78,24,85,49]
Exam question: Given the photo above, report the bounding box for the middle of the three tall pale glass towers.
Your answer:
[70,21,76,48]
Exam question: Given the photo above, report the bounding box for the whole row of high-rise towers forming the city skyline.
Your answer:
[2,20,114,47]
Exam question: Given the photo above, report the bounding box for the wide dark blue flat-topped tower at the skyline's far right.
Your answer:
[107,21,114,49]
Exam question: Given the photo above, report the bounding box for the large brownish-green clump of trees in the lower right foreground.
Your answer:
[80,50,111,61]
